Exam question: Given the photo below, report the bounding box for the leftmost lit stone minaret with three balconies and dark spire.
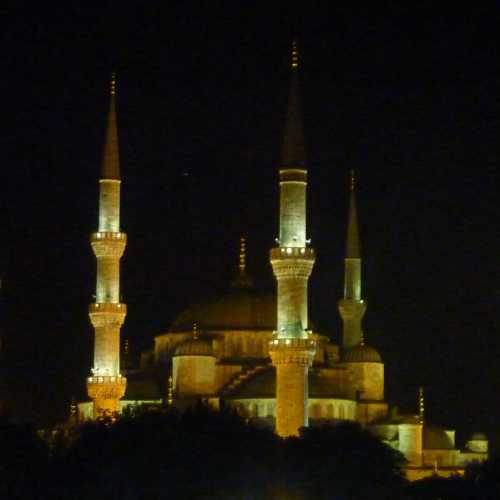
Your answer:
[87,74,127,418]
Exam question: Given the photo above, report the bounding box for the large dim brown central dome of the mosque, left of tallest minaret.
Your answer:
[170,287,276,332]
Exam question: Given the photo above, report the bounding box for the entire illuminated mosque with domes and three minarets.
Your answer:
[78,45,488,479]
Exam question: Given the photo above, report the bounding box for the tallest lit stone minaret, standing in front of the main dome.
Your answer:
[269,42,316,437]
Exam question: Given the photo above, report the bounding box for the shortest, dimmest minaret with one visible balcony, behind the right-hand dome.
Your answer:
[338,170,366,351]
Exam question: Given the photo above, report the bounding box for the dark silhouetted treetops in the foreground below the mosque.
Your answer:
[0,405,500,500]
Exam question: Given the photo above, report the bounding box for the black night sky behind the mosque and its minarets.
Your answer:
[0,2,500,450]
